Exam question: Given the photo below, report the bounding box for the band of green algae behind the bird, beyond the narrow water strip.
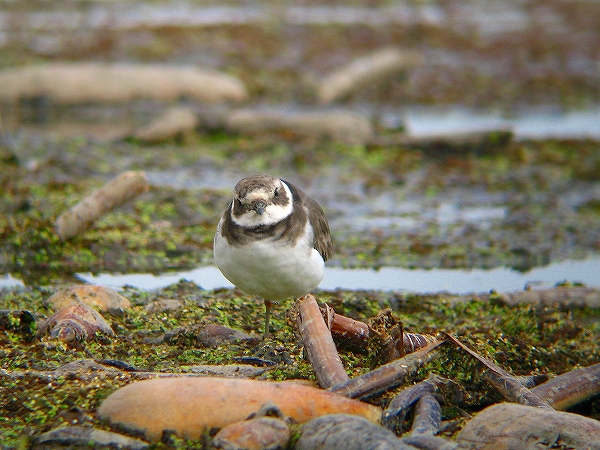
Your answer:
[0,134,600,278]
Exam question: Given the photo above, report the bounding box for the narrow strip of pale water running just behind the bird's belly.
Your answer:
[0,258,580,294]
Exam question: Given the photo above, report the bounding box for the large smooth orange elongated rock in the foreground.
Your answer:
[97,377,381,441]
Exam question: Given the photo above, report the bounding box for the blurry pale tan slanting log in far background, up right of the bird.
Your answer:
[317,47,423,104]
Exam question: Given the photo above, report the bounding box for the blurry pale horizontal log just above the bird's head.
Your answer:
[227,109,373,144]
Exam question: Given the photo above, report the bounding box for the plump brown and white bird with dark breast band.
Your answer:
[214,175,333,337]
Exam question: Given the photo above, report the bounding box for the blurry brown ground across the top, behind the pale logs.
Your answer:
[0,0,600,126]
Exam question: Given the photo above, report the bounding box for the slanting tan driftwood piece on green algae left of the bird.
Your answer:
[55,172,150,241]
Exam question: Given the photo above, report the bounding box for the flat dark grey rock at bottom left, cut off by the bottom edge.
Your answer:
[32,426,149,450]
